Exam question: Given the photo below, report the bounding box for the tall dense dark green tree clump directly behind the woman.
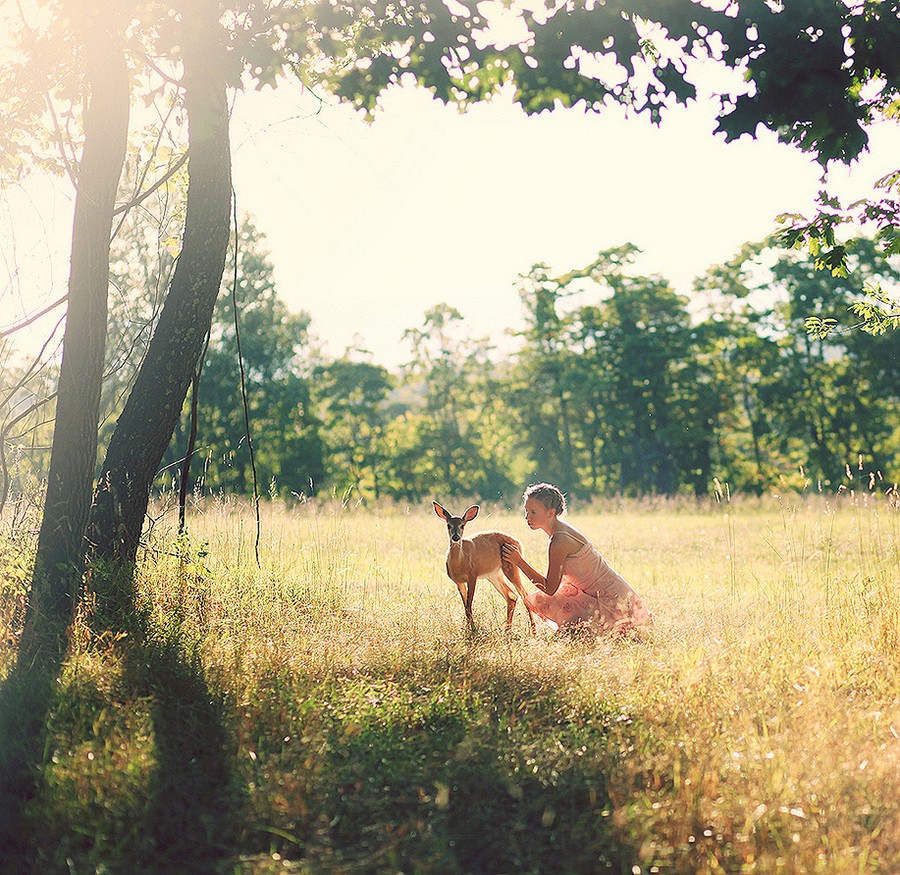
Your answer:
[513,246,725,494]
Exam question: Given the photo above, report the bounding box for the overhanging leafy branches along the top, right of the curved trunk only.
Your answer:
[270,0,900,165]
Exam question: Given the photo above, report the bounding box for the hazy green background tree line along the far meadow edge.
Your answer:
[5,218,900,501]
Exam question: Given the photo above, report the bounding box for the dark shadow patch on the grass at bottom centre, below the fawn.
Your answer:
[292,660,637,875]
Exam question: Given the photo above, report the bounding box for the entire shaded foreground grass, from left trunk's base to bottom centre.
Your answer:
[7,589,636,875]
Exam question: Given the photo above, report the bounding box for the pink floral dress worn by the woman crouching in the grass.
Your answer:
[525,543,653,634]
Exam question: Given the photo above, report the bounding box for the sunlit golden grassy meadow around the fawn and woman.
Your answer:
[0,491,900,875]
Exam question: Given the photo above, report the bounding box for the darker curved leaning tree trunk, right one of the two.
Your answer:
[89,2,231,570]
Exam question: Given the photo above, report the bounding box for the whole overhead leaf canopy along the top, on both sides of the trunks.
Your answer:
[7,0,900,174]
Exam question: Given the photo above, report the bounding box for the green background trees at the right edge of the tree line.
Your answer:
[707,239,900,486]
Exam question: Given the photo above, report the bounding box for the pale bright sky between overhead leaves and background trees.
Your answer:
[0,69,900,368]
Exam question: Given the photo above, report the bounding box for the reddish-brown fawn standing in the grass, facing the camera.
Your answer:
[431,501,534,635]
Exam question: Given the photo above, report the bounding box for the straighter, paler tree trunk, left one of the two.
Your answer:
[19,15,129,663]
